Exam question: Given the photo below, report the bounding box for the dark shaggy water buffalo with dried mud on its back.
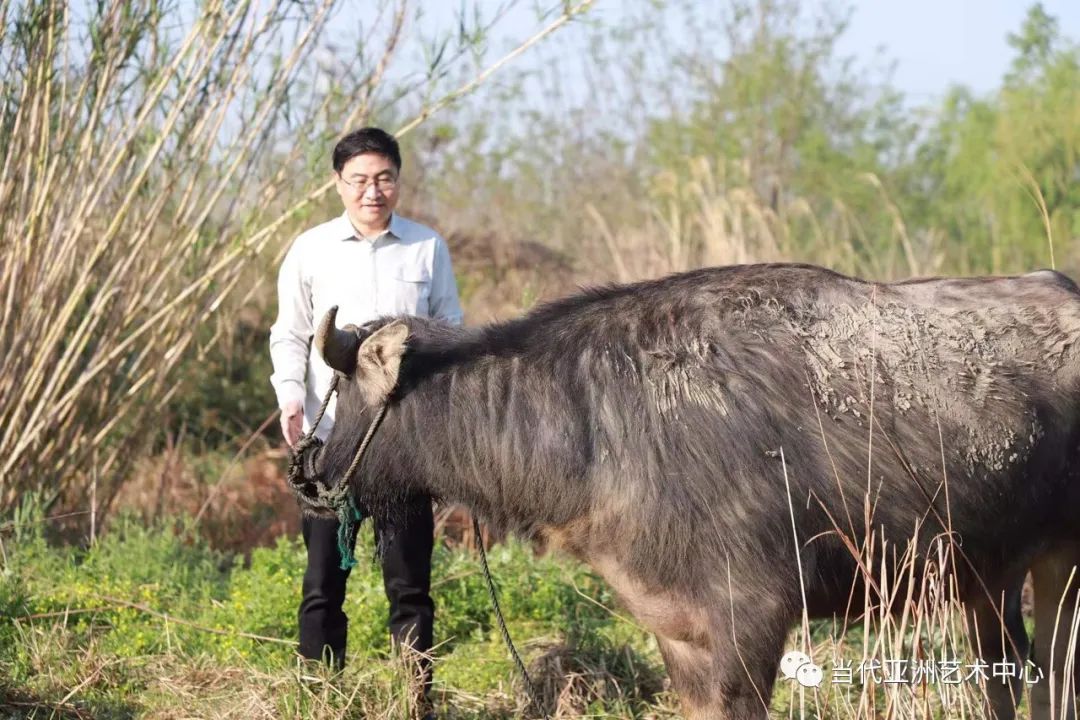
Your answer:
[302,264,1080,720]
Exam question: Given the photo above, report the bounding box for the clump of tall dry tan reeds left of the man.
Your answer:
[0,0,592,512]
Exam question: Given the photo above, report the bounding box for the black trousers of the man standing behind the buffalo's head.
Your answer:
[298,500,435,683]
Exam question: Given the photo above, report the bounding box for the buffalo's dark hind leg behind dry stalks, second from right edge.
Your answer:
[970,575,1028,720]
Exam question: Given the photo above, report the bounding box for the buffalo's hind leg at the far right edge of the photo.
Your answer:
[1031,547,1080,720]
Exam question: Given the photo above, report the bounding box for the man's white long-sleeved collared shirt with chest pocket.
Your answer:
[270,213,461,439]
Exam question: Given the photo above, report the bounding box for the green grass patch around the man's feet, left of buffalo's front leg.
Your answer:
[0,518,675,719]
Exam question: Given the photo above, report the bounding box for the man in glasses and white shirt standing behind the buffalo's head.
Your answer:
[270,127,461,695]
